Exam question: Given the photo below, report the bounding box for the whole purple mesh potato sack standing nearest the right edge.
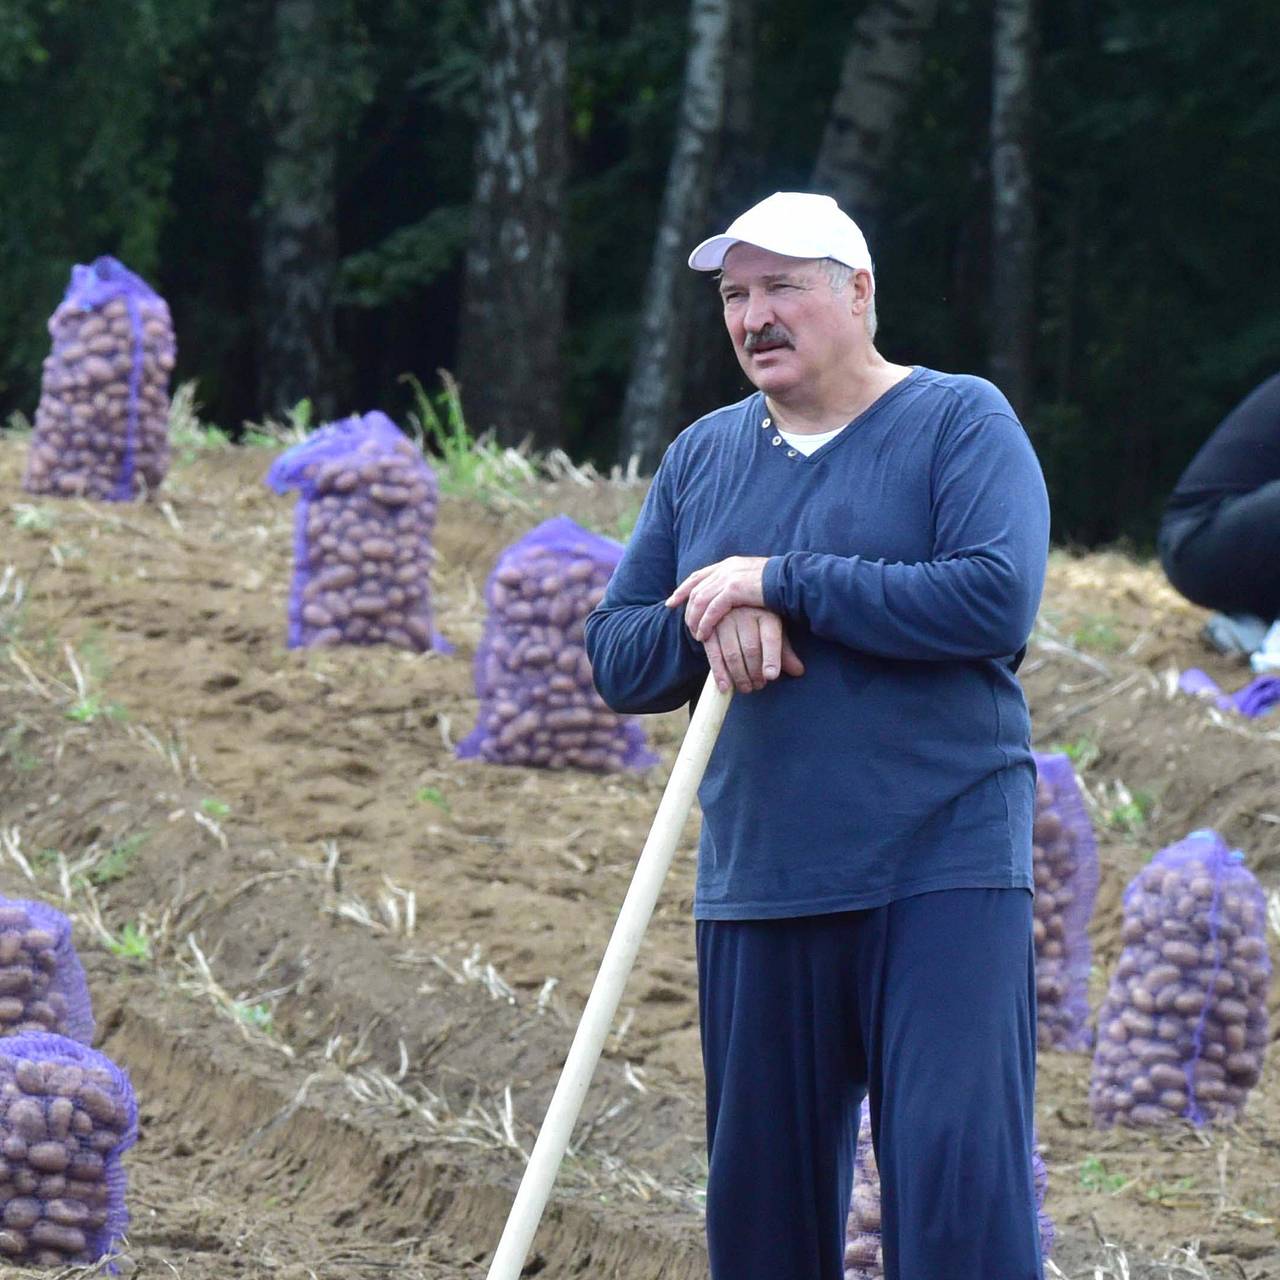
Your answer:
[1089,831,1271,1128]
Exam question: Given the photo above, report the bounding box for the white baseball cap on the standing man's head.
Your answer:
[689,191,873,271]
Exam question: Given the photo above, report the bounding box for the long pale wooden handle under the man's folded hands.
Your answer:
[489,676,733,1280]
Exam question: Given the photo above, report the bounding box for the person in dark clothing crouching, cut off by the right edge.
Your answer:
[1160,374,1280,652]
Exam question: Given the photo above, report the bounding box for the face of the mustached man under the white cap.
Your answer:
[719,244,865,396]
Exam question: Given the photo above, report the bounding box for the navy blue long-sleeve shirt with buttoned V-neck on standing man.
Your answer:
[586,369,1048,919]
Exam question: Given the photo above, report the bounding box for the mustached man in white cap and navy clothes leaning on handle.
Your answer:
[586,192,1048,1280]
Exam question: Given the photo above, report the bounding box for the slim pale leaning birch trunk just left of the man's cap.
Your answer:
[618,0,733,472]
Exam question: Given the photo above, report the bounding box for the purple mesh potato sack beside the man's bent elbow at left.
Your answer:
[458,516,657,771]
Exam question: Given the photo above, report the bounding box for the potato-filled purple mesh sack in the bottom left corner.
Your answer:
[0,1032,138,1266]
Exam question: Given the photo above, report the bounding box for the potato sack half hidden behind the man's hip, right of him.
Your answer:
[1032,754,1098,1050]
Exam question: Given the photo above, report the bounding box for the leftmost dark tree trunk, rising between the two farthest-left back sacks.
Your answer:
[260,0,340,417]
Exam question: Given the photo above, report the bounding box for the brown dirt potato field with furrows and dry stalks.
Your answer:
[0,439,1280,1280]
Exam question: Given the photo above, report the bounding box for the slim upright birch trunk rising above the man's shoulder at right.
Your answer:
[991,0,1036,413]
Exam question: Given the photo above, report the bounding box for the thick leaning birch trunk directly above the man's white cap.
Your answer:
[812,0,938,235]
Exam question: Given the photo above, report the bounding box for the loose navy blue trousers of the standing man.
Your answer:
[698,890,1042,1280]
